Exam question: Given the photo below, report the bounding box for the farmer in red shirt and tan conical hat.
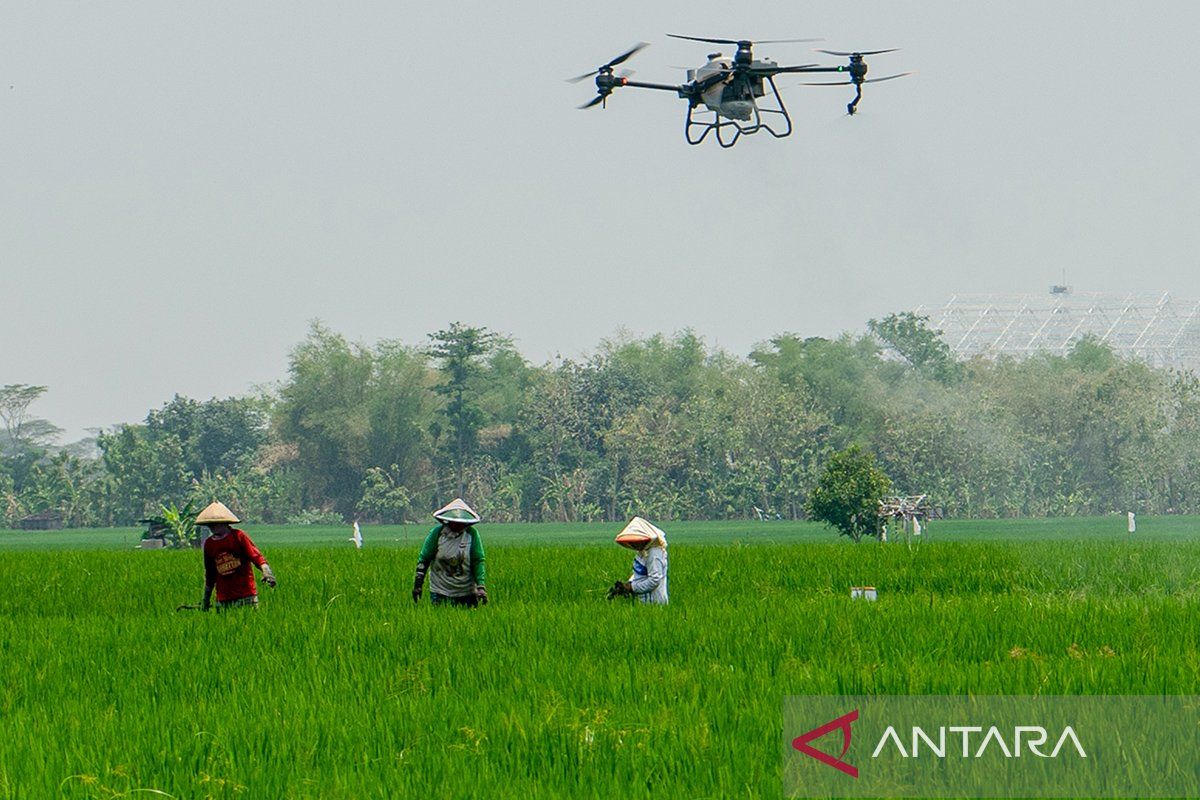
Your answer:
[196,503,275,610]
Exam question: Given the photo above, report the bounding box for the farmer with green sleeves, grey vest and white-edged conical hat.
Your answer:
[413,498,487,607]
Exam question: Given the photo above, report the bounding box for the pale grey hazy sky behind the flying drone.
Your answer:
[0,0,1200,438]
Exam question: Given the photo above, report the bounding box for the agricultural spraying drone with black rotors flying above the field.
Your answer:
[569,34,912,148]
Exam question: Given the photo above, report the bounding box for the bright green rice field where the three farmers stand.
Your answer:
[0,518,1200,799]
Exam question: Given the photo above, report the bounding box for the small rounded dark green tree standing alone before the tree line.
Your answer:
[806,445,892,542]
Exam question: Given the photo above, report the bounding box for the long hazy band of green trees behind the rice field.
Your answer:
[0,313,1200,527]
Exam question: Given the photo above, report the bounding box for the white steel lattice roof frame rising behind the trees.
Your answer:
[916,292,1200,371]
